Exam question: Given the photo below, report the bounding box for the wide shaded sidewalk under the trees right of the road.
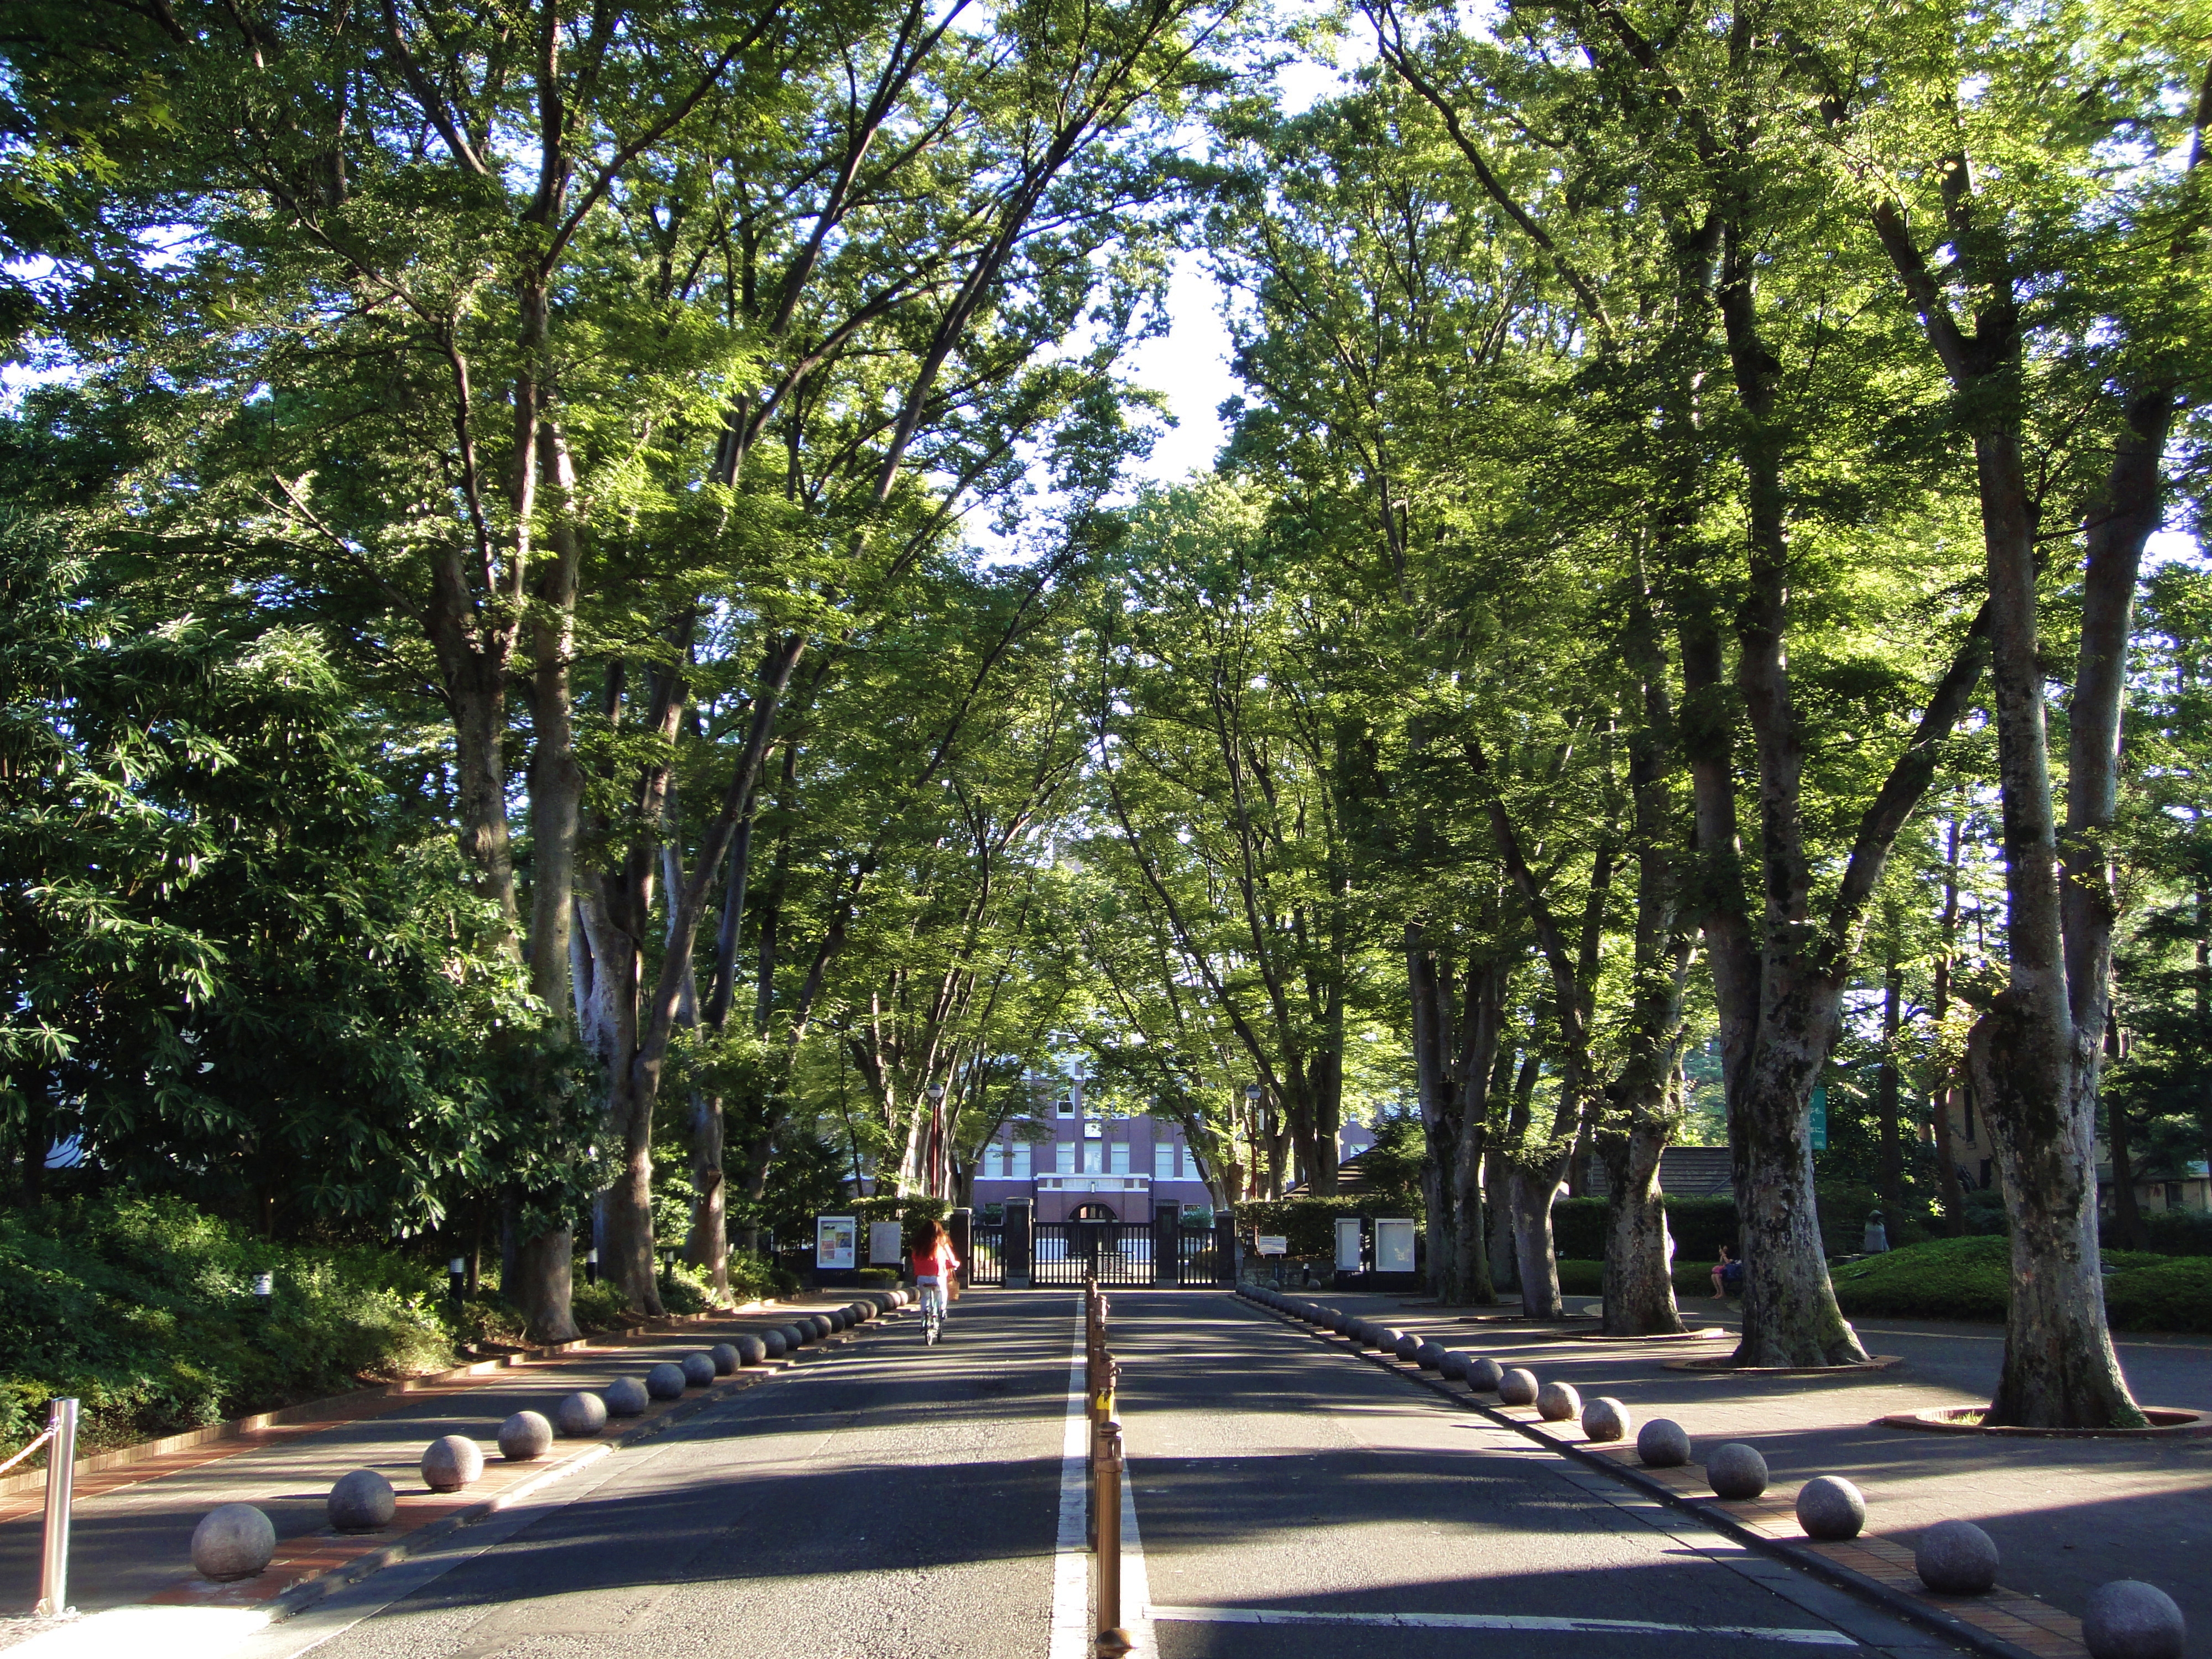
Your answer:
[1265,1292,2212,1657]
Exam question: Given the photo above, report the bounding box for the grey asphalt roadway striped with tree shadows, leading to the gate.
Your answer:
[241,1292,1951,1659]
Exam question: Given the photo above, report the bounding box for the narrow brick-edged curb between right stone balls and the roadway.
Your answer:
[1237,1296,2088,1659]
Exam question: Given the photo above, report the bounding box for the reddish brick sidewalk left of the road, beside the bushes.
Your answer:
[0,1296,896,1646]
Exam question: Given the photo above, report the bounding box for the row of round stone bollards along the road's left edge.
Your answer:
[192,1290,914,1584]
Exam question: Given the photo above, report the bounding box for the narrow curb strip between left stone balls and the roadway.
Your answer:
[150,1310,905,1624]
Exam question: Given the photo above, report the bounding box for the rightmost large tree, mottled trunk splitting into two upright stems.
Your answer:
[1820,7,2212,1427]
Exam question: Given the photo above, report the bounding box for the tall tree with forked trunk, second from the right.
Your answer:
[1369,4,1986,1365]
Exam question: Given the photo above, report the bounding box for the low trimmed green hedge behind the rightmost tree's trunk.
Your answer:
[1834,1234,2212,1332]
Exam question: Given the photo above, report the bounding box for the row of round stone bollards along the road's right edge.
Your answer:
[1239,1285,2188,1659]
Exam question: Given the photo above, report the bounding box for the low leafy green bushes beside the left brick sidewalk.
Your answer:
[0,1197,453,1449]
